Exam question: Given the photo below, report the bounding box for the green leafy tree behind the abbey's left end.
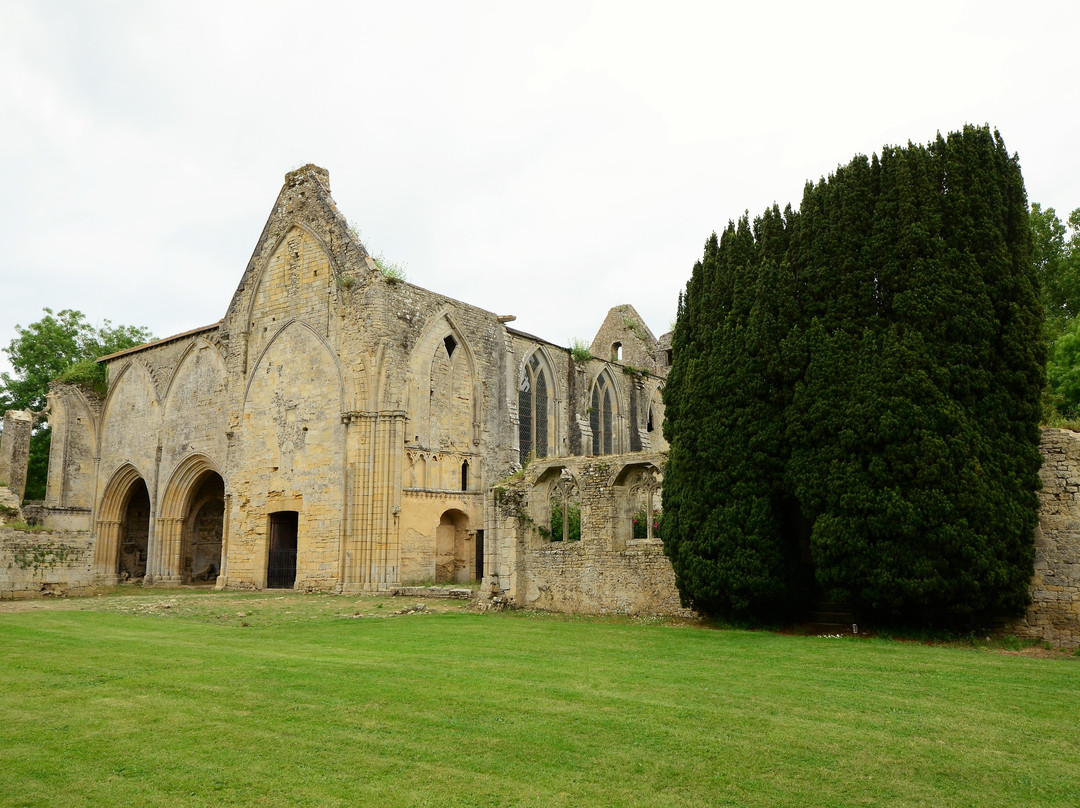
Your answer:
[0,308,152,499]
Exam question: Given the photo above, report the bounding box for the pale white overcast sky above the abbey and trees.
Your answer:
[0,0,1080,378]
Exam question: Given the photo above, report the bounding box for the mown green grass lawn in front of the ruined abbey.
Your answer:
[0,589,1080,808]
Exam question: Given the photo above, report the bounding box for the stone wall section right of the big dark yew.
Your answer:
[1009,429,1080,648]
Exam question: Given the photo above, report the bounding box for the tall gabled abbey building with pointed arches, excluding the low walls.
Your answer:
[2,165,666,608]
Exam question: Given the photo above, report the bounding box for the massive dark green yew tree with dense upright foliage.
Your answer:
[664,126,1044,629]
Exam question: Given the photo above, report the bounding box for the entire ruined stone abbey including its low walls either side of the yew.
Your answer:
[0,165,1080,645]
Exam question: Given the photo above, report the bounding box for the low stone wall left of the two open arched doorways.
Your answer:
[0,527,93,600]
